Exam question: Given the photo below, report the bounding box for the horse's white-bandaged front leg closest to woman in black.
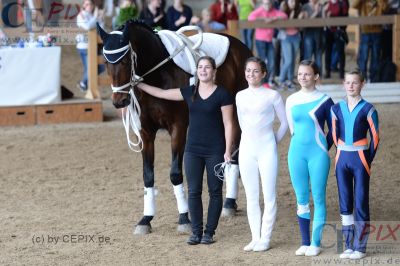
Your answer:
[170,125,192,233]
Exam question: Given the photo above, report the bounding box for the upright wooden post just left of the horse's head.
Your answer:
[85,29,100,99]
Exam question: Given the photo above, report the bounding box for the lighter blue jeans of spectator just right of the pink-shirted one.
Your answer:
[279,33,300,83]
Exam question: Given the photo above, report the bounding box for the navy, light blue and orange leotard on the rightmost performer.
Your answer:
[331,99,379,253]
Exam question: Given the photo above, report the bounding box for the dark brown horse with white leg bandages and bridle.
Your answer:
[97,20,252,234]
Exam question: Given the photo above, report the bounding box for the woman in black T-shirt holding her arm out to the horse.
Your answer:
[137,56,234,245]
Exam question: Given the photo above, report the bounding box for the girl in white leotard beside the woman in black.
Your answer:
[236,57,288,251]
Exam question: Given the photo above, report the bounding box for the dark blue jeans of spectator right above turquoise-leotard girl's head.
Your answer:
[303,30,323,76]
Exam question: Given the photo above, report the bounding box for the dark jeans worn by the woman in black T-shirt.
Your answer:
[183,152,224,236]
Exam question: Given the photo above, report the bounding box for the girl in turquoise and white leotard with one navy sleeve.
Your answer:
[286,60,333,256]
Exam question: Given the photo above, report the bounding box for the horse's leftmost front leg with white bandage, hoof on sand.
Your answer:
[134,130,156,235]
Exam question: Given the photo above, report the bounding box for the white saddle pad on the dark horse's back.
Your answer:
[158,30,229,75]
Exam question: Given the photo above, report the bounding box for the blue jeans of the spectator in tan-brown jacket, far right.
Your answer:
[357,33,381,82]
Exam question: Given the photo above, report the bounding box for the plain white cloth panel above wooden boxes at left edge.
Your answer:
[0,47,61,106]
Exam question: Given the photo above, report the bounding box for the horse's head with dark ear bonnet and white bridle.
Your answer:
[97,24,136,108]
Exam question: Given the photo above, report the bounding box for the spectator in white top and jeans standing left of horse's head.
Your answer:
[76,0,105,92]
